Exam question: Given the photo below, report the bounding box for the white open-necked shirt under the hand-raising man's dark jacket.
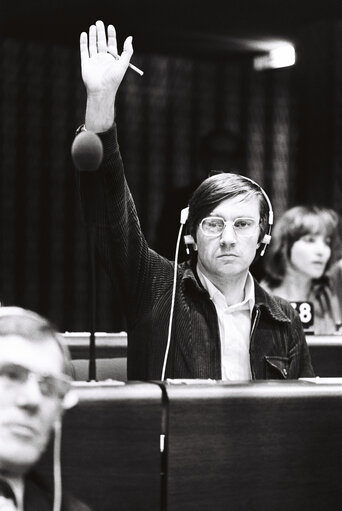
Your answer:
[197,266,255,380]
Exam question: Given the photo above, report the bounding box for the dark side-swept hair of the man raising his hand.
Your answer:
[188,172,269,241]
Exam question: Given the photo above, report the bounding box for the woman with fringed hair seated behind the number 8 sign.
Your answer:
[261,206,342,335]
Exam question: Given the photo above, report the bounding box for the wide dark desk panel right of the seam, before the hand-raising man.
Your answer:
[165,382,342,511]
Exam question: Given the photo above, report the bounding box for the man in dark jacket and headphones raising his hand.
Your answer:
[78,21,313,380]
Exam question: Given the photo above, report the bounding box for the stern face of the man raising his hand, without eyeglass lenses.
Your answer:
[196,196,260,282]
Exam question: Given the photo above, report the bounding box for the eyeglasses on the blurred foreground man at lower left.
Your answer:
[0,363,71,399]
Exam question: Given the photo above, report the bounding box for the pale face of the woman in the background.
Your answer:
[290,234,331,279]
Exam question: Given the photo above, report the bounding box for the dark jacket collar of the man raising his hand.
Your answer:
[181,261,291,323]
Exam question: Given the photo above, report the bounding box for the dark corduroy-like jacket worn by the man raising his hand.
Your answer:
[79,126,313,380]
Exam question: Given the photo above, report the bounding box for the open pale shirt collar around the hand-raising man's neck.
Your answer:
[196,264,255,314]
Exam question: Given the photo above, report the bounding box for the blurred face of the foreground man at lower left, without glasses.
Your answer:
[0,335,62,475]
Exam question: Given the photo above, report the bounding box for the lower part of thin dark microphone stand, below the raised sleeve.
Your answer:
[88,226,96,381]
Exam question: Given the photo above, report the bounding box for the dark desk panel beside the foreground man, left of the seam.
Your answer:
[36,383,162,511]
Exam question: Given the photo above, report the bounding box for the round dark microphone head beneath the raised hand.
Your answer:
[71,131,103,171]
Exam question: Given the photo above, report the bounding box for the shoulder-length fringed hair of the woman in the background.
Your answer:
[264,206,339,288]
